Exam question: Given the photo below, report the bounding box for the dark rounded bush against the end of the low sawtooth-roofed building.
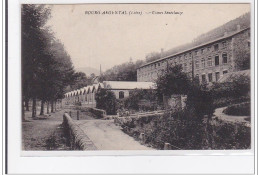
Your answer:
[95,89,116,115]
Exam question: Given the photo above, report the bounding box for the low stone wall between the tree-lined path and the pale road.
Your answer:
[63,113,97,150]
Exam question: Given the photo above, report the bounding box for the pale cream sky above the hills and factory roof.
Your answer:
[48,4,250,71]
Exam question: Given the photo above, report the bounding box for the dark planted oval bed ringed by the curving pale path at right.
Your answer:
[223,103,251,116]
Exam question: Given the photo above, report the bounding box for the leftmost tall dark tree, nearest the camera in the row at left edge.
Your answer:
[22,4,50,120]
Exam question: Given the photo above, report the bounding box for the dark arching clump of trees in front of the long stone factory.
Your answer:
[156,65,213,119]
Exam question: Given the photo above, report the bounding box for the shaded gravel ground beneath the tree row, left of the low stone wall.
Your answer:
[22,110,69,151]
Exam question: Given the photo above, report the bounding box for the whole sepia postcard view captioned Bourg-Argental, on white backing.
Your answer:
[19,3,255,151]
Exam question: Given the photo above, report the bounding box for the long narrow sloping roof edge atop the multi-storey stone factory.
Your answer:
[137,27,250,69]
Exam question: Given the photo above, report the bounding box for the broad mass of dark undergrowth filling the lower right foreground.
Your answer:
[121,110,251,150]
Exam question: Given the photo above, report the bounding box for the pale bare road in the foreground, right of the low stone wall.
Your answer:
[75,120,152,150]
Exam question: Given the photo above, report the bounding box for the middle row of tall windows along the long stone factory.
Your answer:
[140,53,228,77]
